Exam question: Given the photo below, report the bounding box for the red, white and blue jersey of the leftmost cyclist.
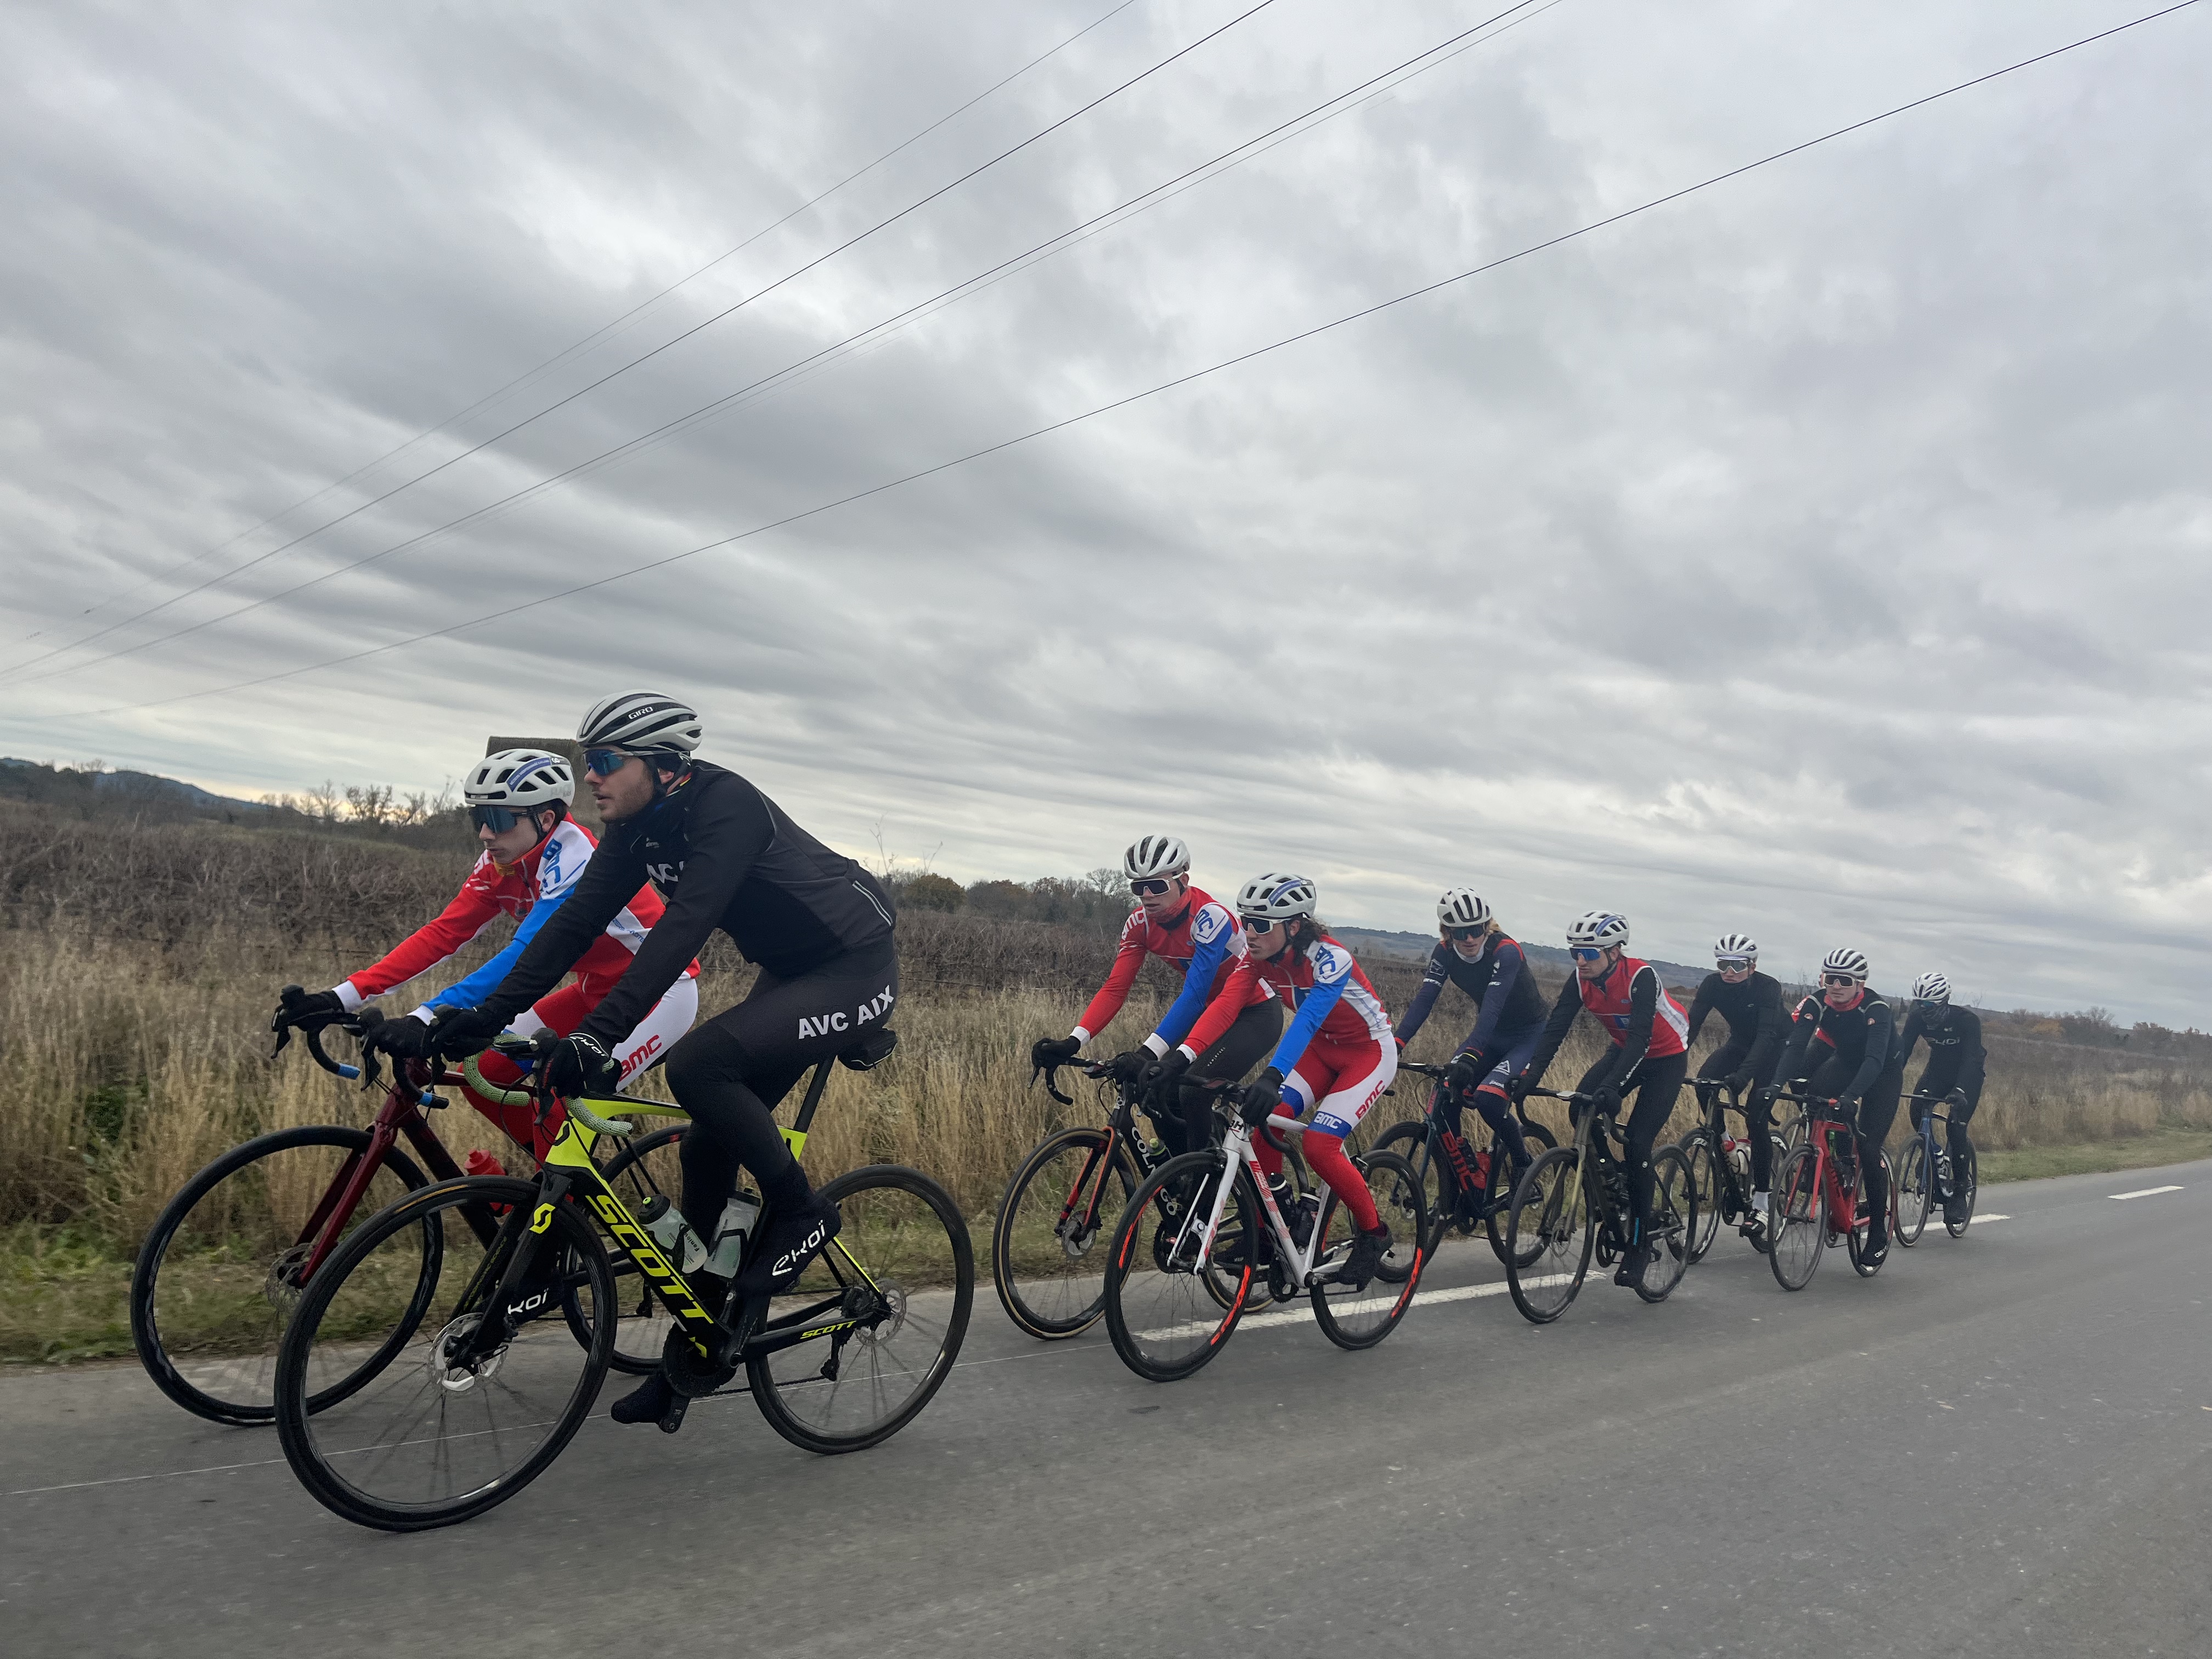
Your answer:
[332,819,699,1037]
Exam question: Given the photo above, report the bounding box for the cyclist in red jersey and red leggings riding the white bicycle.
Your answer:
[1183,874,1398,1285]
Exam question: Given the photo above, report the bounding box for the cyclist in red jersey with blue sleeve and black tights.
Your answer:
[1029,836,1283,1153]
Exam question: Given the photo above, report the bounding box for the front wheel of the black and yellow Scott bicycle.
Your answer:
[276,1175,615,1533]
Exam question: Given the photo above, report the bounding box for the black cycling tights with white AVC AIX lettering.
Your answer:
[668,940,898,1239]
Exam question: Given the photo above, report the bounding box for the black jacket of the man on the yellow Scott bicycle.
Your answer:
[484,761,891,1046]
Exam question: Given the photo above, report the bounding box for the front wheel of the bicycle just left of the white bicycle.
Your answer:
[991,1126,1137,1342]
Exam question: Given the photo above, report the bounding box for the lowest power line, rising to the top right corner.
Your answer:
[80,0,2199,716]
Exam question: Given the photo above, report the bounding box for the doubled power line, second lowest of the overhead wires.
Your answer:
[15,0,1564,686]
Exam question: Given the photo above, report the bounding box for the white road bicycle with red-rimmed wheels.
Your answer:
[1106,1082,1429,1383]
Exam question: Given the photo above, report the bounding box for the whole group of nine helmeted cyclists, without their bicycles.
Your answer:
[279,690,1982,1423]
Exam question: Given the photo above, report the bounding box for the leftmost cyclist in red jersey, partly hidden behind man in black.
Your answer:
[285,750,699,1159]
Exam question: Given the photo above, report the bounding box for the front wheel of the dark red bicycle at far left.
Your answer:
[131,1124,438,1425]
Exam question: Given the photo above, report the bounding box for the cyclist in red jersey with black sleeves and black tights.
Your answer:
[1513,909,1690,1285]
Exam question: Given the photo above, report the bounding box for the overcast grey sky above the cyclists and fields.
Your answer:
[0,0,2212,1024]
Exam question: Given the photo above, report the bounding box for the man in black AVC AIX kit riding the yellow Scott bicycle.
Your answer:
[433,692,898,1423]
